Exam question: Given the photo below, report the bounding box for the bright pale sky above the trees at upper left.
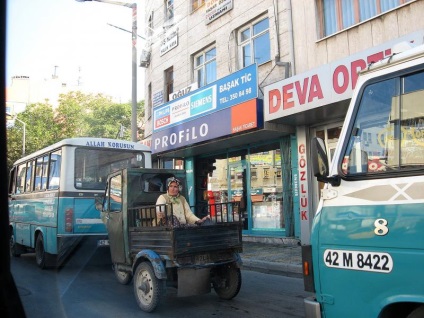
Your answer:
[6,0,144,102]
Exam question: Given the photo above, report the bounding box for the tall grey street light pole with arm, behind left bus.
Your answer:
[76,0,137,141]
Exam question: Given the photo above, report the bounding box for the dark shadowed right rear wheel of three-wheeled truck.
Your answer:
[213,265,241,300]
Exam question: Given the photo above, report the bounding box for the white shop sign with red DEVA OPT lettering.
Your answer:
[264,31,423,121]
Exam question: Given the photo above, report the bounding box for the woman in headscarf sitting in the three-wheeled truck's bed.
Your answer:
[156,177,211,227]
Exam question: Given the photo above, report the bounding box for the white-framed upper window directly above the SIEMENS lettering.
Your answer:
[194,47,216,87]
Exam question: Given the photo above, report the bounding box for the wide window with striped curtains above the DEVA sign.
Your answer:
[318,0,412,37]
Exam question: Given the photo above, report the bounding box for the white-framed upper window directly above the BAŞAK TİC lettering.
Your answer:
[239,18,271,67]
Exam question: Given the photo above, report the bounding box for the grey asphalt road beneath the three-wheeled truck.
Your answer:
[11,241,308,318]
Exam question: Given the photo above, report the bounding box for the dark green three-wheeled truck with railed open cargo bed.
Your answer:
[101,168,242,312]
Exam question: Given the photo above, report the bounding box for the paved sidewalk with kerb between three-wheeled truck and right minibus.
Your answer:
[240,237,302,277]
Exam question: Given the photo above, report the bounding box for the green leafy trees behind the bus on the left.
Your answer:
[7,92,144,168]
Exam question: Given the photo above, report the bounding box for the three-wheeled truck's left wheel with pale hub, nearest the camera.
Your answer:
[134,262,165,312]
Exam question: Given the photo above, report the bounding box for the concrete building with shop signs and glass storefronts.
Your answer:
[141,0,424,243]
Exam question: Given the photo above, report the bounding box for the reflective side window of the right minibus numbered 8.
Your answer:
[342,72,424,176]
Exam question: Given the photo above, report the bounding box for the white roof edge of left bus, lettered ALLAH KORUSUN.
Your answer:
[15,137,150,164]
